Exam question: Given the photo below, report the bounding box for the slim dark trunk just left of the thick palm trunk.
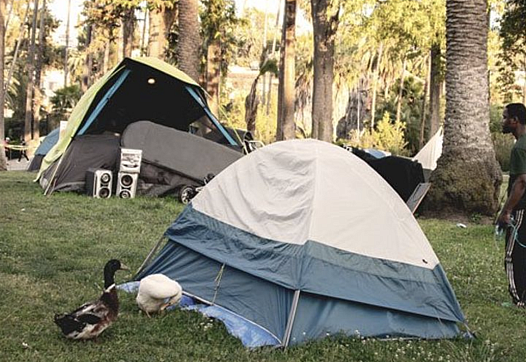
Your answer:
[429,43,443,138]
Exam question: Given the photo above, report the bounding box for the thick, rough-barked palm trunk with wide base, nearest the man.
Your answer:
[426,0,502,216]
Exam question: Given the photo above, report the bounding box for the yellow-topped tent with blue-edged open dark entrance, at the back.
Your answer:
[37,57,243,191]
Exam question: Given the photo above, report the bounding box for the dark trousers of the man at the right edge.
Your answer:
[504,209,526,306]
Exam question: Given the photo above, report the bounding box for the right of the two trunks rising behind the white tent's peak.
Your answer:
[311,0,338,142]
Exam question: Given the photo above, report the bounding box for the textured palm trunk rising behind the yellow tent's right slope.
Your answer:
[177,0,201,82]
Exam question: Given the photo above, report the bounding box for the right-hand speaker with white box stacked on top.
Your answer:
[115,148,142,199]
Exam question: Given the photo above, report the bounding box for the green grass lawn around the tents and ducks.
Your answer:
[0,172,526,362]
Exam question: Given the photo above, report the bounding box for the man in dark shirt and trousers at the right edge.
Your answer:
[497,103,526,307]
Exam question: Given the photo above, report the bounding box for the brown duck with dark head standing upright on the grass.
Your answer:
[54,259,129,340]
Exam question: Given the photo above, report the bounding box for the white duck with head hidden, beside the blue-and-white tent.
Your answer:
[135,274,183,317]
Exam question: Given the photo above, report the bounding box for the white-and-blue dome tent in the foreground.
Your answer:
[136,140,465,346]
